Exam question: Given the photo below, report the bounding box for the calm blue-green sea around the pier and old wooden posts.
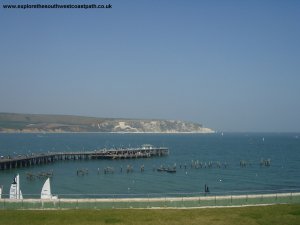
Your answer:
[0,132,300,198]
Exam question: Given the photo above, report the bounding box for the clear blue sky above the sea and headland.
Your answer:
[0,0,300,132]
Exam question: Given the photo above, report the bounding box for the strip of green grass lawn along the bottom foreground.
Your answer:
[0,204,300,225]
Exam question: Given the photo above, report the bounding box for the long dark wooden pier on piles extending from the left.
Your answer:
[0,146,169,170]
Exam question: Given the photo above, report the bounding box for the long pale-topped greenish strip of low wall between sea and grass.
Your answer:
[0,192,300,209]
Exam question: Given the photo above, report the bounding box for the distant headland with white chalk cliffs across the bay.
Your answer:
[0,113,214,133]
